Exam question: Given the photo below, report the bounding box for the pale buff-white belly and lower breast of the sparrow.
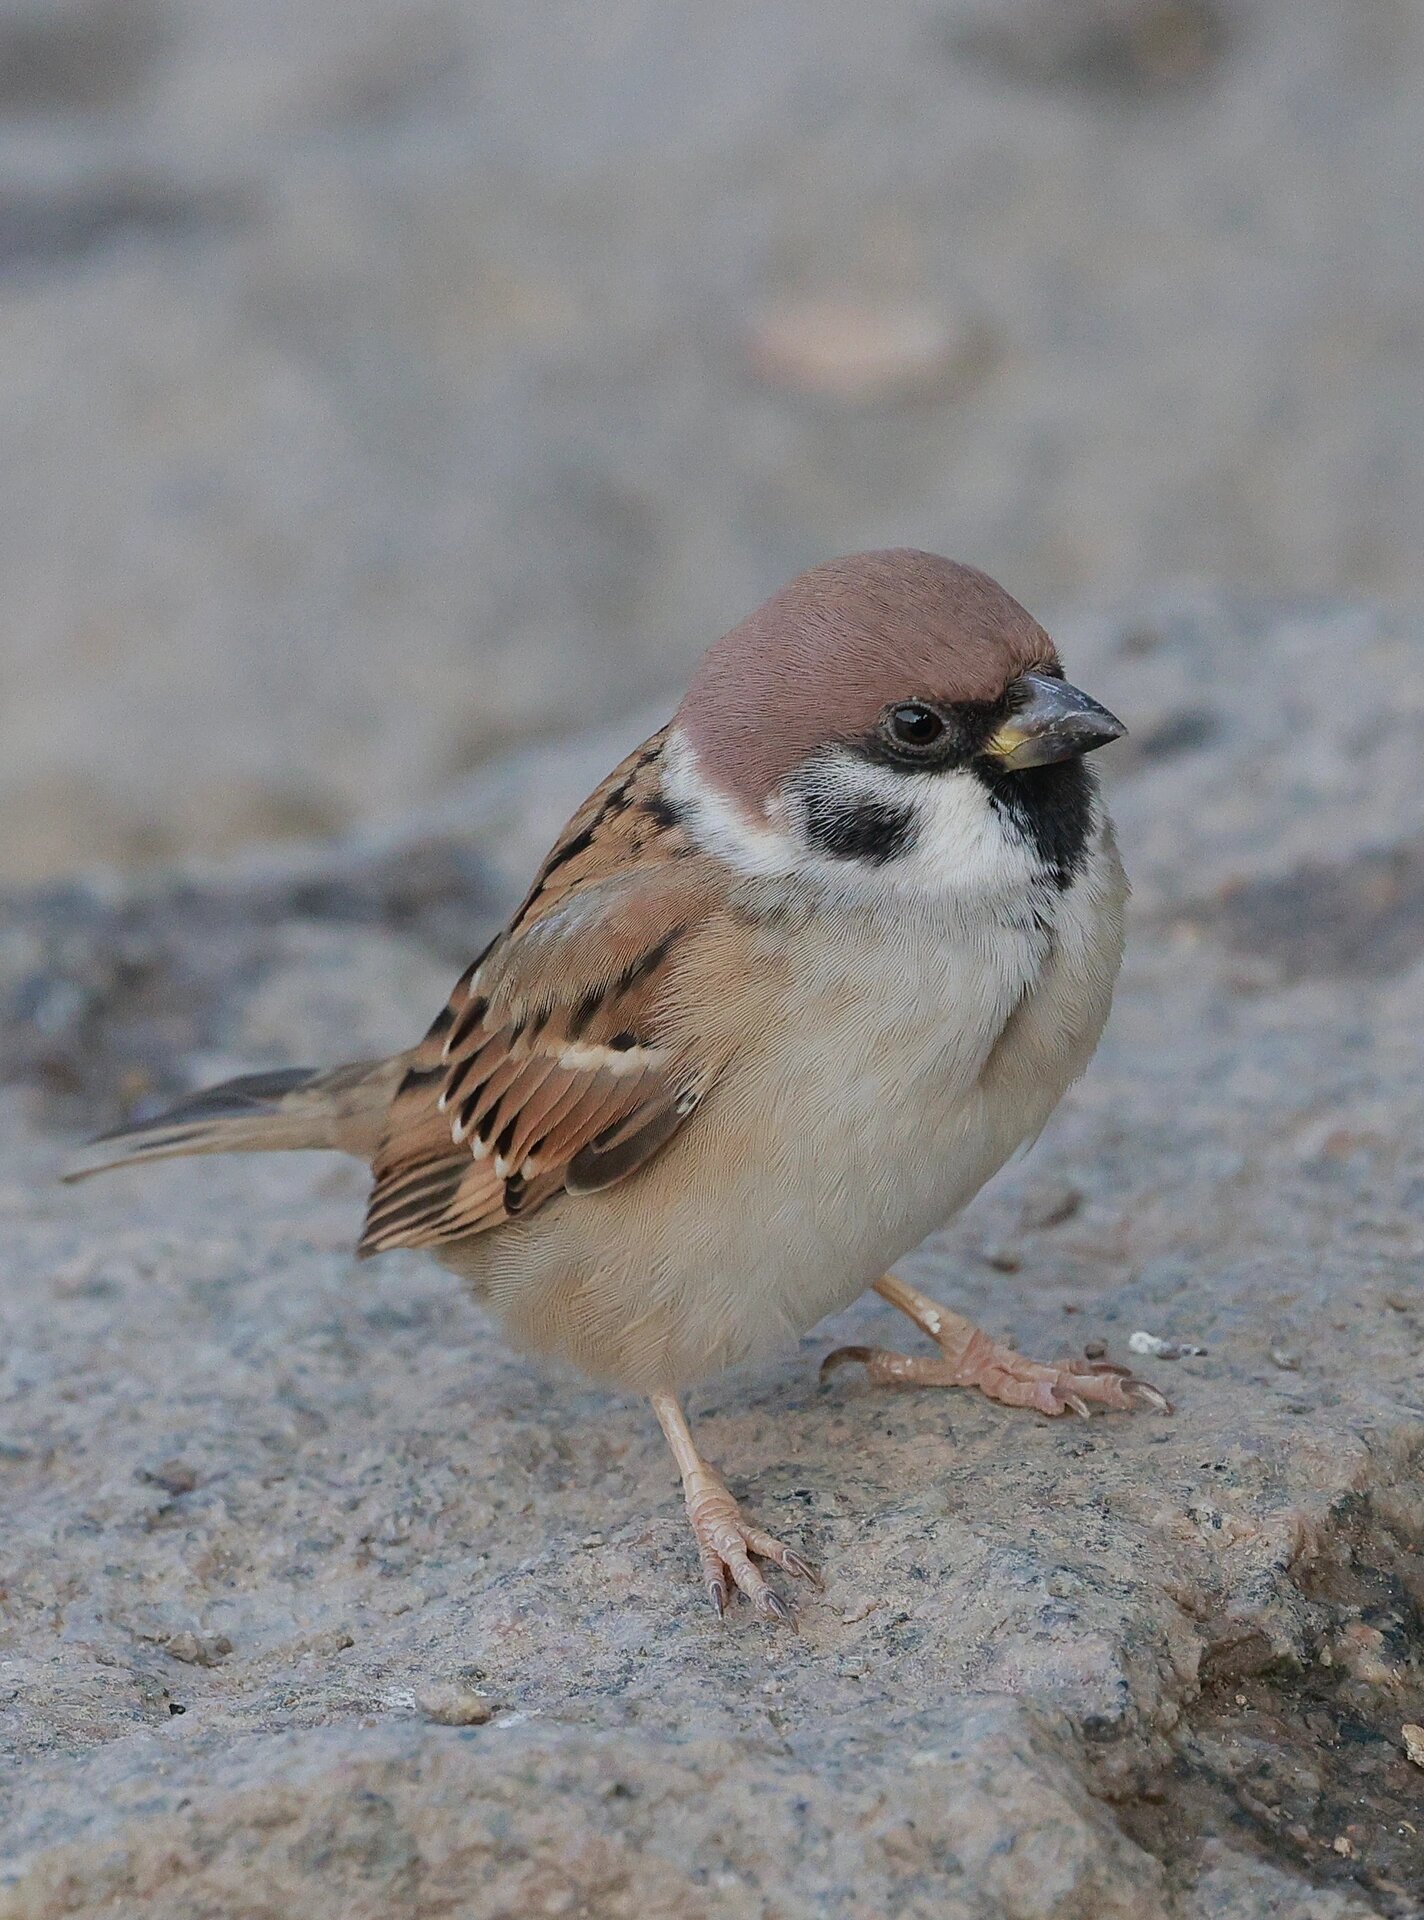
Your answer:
[462,906,1061,1390]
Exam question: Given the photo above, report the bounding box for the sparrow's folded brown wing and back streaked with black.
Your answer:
[361,733,724,1254]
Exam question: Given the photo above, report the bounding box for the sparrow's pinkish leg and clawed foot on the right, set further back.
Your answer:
[821,1273,1171,1419]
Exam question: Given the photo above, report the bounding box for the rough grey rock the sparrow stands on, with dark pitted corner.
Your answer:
[0,599,1424,1920]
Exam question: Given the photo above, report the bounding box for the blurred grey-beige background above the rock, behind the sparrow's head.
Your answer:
[0,0,1424,881]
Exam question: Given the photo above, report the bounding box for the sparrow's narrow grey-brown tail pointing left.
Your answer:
[65,1054,411,1181]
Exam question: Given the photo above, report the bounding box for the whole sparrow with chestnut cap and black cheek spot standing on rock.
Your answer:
[69,547,1167,1622]
